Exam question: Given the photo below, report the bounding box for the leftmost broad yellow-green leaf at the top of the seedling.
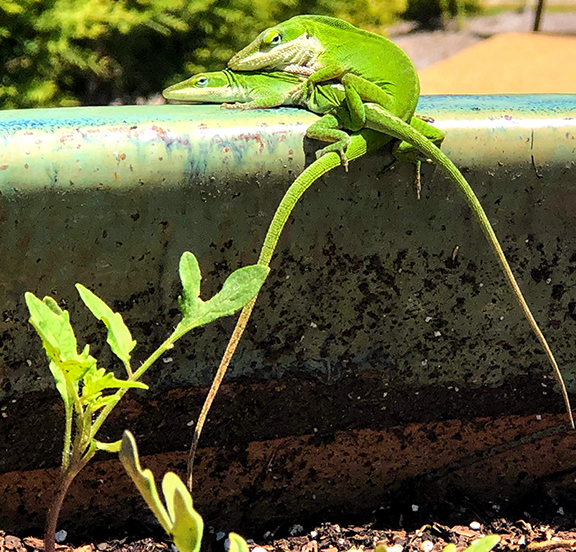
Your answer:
[25,292,96,382]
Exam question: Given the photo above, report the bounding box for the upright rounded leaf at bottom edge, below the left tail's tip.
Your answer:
[162,472,204,552]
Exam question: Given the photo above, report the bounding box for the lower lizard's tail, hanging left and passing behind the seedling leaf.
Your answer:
[187,129,388,492]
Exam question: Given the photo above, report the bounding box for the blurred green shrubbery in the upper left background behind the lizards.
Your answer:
[0,0,405,109]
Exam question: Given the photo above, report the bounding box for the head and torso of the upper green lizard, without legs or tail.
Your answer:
[228,15,420,125]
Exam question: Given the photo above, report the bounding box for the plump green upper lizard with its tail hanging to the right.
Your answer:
[223,15,574,422]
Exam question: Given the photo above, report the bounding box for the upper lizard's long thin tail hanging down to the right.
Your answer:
[365,104,574,429]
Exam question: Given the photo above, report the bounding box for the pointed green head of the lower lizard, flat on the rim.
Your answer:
[162,71,238,103]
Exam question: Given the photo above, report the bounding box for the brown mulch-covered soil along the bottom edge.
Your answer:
[0,518,576,552]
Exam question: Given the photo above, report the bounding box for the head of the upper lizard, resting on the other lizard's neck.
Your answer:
[228,17,324,75]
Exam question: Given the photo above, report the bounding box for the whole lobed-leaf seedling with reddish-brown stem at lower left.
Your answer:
[25,252,269,552]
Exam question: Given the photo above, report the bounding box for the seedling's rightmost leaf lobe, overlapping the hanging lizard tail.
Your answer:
[180,265,270,330]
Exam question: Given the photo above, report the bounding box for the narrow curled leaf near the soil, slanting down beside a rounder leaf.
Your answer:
[118,431,170,532]
